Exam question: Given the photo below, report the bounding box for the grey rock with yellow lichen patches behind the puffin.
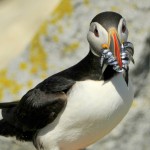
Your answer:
[0,0,150,150]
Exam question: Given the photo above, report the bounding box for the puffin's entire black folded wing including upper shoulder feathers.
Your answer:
[2,76,75,131]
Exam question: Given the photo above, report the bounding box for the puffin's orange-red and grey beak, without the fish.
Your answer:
[109,28,122,68]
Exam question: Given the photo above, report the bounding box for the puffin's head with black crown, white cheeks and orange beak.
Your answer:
[87,11,128,67]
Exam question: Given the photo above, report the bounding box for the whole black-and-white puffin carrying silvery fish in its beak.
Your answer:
[0,11,134,150]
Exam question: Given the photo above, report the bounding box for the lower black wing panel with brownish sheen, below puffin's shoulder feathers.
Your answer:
[15,89,67,131]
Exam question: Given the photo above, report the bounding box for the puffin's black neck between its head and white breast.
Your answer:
[57,50,118,81]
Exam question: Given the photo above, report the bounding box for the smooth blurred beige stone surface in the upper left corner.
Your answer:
[0,0,60,69]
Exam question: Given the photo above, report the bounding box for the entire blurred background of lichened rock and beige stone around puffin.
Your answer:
[0,0,150,150]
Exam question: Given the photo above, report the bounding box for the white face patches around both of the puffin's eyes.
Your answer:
[87,18,128,56]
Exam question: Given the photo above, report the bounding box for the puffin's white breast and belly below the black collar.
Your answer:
[38,73,133,150]
